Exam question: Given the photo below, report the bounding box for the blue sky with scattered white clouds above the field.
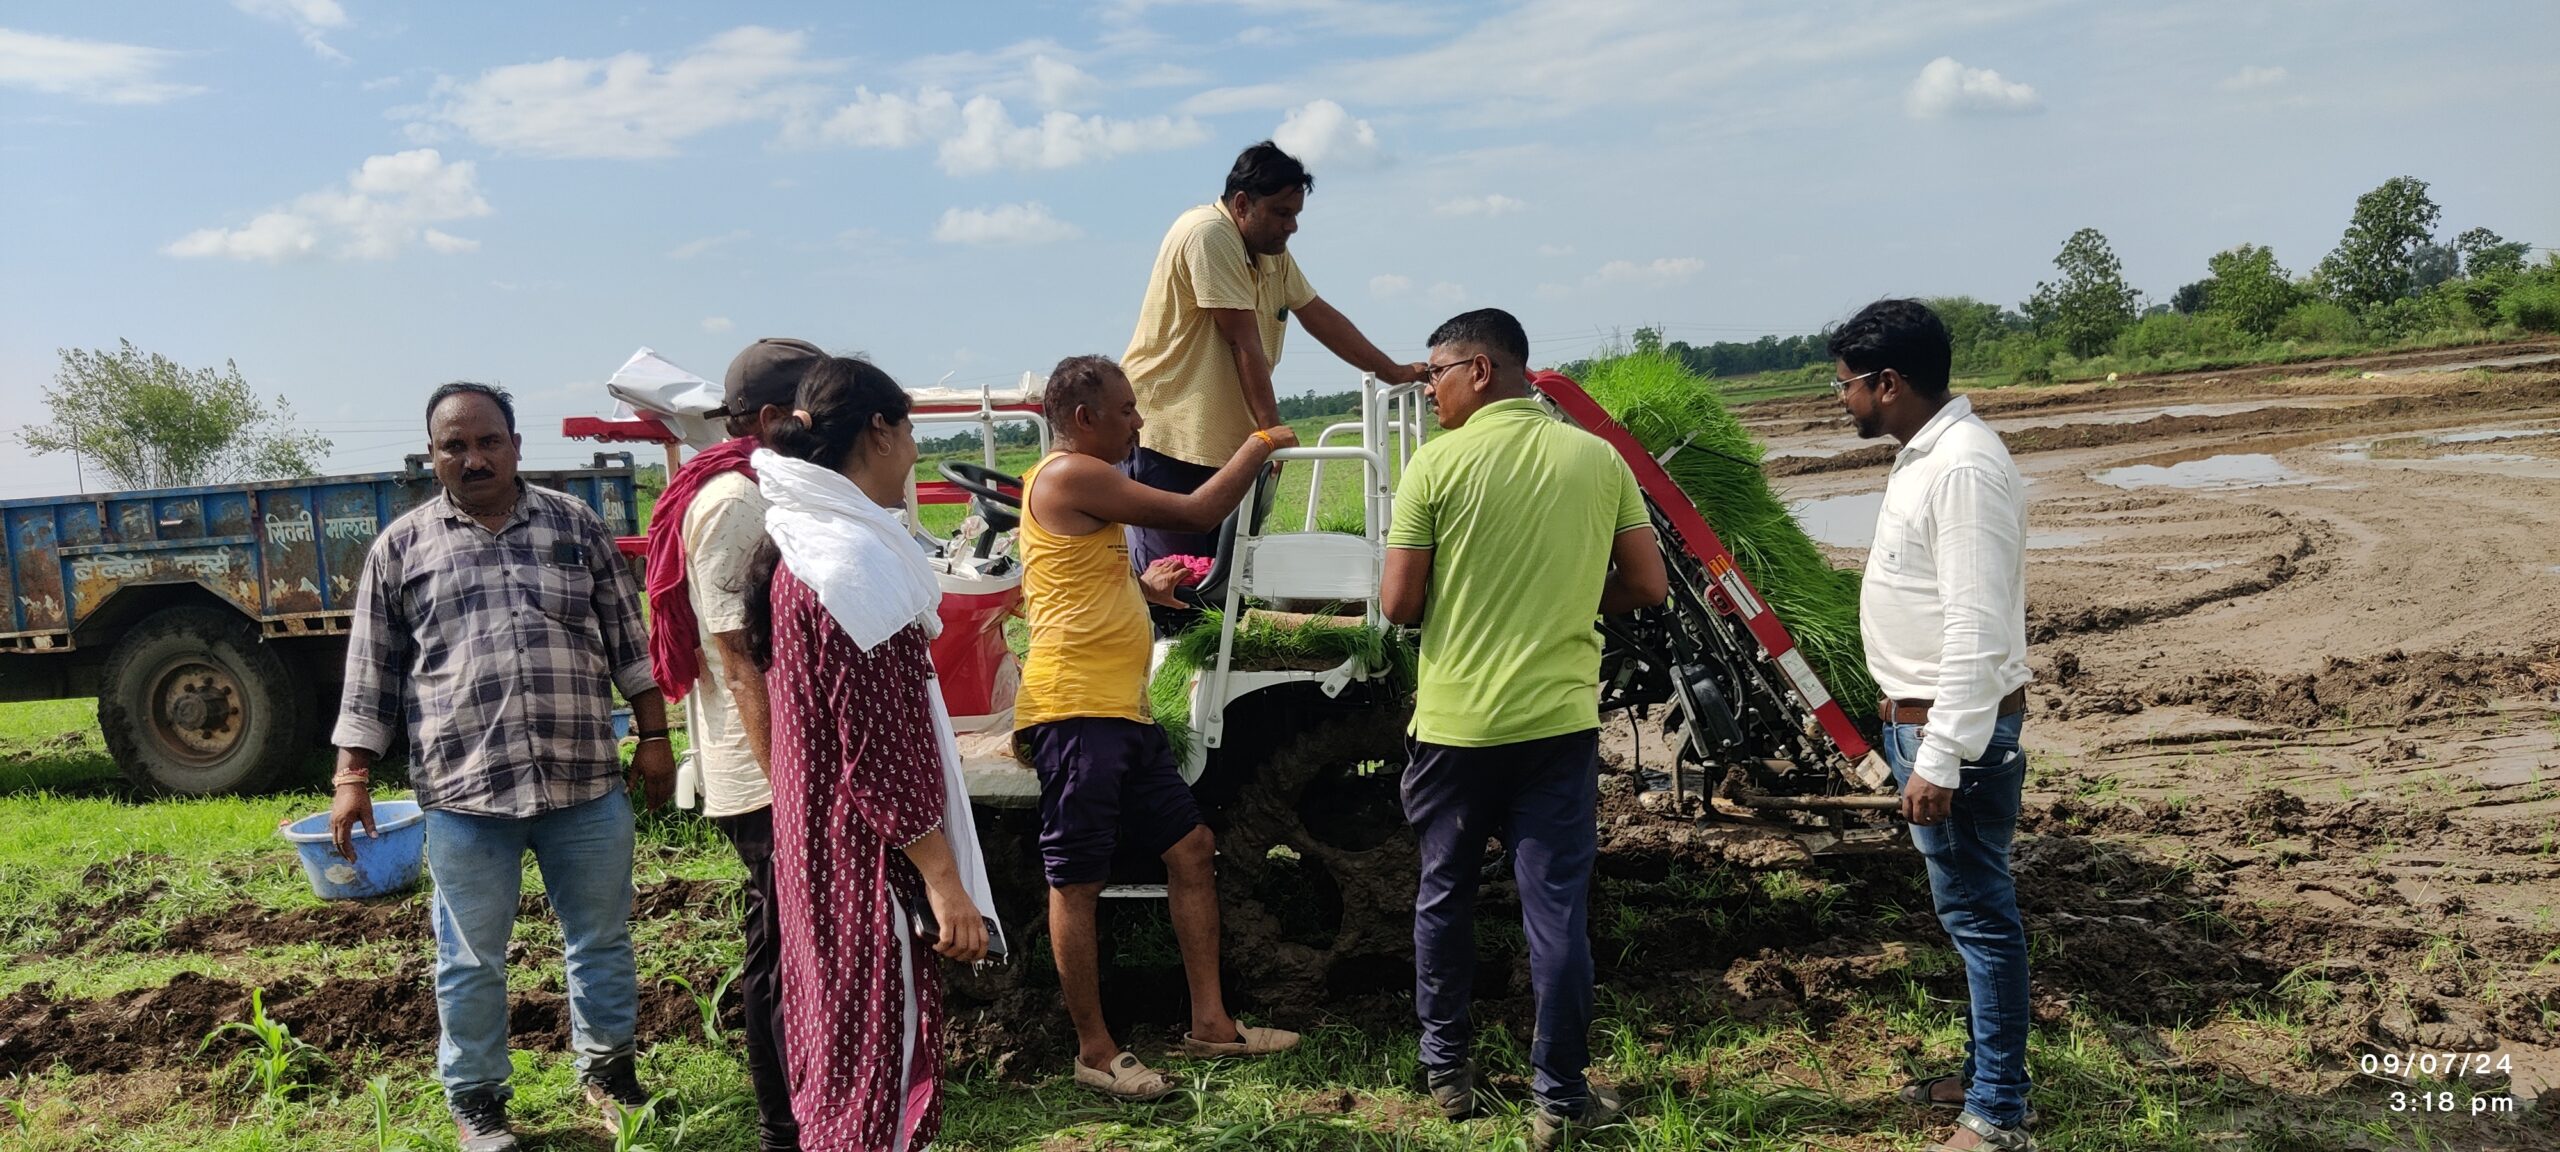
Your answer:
[0,0,2560,497]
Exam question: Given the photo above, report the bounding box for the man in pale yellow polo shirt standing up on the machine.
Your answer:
[1121,141,1421,571]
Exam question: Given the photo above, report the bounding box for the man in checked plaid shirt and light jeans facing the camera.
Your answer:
[330,384,676,1152]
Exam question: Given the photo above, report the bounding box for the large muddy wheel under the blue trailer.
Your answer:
[97,607,317,796]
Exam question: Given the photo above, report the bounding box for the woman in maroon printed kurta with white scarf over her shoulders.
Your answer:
[748,358,986,1152]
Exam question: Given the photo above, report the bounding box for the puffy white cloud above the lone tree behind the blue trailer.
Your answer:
[161,148,489,264]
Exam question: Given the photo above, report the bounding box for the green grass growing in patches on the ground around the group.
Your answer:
[0,696,2522,1152]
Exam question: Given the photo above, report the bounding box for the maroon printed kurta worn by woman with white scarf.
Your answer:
[765,568,942,1152]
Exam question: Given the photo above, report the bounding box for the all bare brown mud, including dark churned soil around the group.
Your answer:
[0,346,2560,1149]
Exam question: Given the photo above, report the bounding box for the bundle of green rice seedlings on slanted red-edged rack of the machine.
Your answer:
[1582,353,1876,719]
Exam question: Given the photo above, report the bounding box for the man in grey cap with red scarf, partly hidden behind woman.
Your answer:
[648,338,827,1152]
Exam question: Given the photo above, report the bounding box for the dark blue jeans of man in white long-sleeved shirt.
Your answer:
[1884,717,2028,1129]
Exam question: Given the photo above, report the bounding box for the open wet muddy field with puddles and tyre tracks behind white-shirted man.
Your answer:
[1748,346,2560,1119]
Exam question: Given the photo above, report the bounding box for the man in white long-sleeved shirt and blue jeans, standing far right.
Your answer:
[1830,300,2035,1152]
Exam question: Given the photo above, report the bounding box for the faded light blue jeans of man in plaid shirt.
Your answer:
[428,788,640,1101]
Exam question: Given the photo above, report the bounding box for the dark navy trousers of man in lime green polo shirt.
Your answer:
[1403,730,1600,1116]
